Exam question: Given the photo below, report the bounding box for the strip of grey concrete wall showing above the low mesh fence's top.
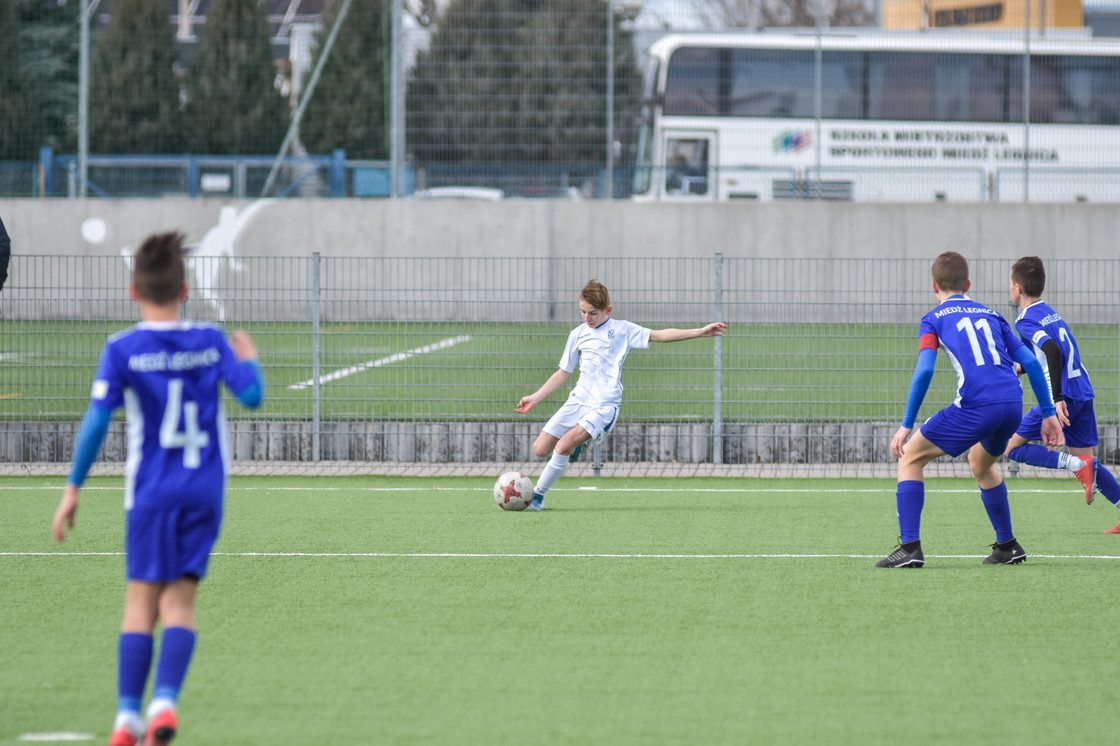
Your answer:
[0,199,1120,259]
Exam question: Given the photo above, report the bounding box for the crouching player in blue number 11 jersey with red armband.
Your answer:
[876,251,1062,568]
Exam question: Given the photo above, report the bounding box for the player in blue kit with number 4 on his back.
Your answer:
[53,233,264,746]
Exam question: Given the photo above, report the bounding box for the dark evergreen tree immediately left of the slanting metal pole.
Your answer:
[185,0,290,156]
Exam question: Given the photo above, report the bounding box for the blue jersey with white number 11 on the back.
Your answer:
[918,296,1023,407]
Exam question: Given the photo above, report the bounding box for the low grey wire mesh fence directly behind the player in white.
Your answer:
[0,254,1120,476]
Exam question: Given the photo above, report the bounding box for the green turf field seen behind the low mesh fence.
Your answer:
[0,319,1120,423]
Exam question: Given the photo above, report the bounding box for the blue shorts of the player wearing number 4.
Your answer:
[124,505,222,582]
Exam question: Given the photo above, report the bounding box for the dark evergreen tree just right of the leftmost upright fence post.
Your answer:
[90,0,184,155]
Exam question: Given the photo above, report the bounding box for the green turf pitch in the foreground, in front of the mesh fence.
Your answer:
[0,477,1120,746]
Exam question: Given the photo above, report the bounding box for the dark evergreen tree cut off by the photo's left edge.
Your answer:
[0,0,39,160]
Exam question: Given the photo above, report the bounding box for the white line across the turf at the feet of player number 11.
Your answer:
[0,552,1120,560]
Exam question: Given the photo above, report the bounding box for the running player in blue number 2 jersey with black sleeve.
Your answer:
[1007,257,1120,533]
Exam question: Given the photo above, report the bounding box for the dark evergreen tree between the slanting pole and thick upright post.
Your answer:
[299,0,391,159]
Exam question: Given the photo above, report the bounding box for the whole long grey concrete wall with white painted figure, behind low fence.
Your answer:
[0,199,1120,323]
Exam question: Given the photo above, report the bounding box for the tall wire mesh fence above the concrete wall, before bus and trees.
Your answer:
[0,0,1120,202]
